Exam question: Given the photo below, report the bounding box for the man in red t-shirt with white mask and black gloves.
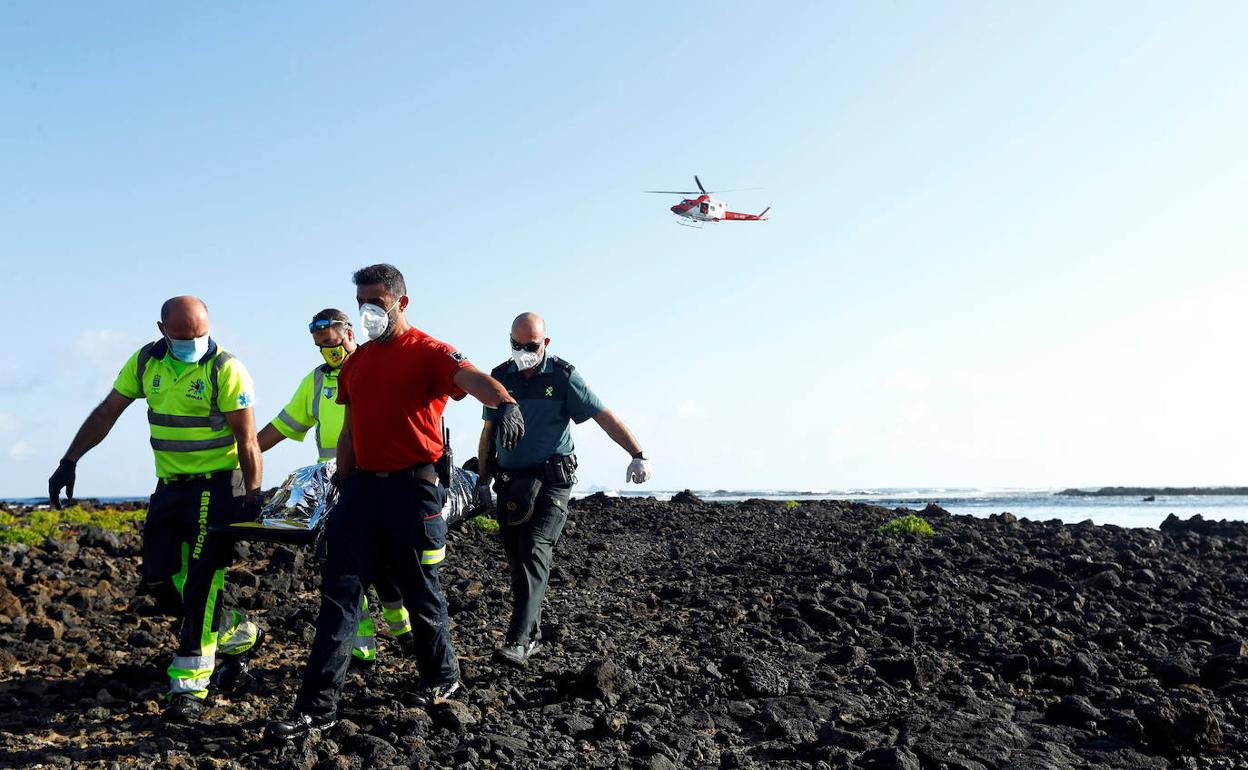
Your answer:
[267,265,524,739]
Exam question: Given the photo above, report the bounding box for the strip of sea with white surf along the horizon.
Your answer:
[7,487,1248,528]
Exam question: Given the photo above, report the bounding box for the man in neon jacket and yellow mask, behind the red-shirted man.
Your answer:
[260,307,416,663]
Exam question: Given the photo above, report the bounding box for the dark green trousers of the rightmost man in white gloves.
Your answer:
[498,479,572,644]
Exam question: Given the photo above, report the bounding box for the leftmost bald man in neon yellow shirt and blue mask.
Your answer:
[47,297,263,721]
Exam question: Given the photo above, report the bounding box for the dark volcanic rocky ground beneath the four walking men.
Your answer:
[0,495,1248,770]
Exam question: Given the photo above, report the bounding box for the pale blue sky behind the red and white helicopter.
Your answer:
[0,2,1248,497]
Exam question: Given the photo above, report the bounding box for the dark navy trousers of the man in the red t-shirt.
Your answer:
[295,472,459,714]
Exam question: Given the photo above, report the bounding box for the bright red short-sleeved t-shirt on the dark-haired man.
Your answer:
[338,327,472,470]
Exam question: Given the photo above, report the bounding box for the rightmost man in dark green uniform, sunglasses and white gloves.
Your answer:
[477,313,650,666]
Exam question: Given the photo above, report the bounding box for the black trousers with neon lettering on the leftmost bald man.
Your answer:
[142,472,250,698]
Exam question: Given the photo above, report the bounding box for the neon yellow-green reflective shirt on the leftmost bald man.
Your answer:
[112,339,255,478]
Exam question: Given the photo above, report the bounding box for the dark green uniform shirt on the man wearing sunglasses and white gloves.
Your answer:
[482,356,603,469]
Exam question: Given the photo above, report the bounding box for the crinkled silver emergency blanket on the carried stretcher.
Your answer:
[230,459,479,542]
